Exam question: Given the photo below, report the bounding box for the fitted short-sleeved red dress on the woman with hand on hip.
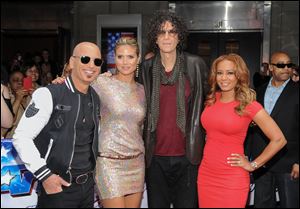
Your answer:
[197,93,262,208]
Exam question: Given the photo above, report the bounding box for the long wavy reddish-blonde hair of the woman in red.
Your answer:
[205,53,256,115]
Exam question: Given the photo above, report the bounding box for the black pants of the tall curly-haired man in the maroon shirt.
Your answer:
[146,156,198,208]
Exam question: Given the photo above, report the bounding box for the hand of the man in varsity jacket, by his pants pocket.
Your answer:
[43,174,71,194]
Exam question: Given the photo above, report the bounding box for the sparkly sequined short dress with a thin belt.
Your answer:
[92,75,146,199]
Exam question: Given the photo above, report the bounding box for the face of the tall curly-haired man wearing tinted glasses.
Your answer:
[156,21,179,53]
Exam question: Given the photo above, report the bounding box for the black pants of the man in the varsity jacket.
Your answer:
[37,177,95,208]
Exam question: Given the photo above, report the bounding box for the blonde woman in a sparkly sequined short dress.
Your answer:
[92,38,146,208]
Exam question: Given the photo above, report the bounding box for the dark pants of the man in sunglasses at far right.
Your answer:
[254,168,299,208]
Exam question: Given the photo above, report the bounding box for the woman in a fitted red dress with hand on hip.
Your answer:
[197,54,286,208]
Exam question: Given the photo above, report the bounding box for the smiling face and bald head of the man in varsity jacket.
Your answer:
[70,42,101,87]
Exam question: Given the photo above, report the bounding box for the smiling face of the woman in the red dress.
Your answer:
[216,60,238,93]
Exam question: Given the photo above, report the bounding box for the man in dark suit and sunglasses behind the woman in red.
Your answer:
[249,52,299,208]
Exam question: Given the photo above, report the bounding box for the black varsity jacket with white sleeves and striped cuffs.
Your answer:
[13,77,100,182]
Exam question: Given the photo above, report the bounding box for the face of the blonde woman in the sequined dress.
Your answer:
[115,45,139,77]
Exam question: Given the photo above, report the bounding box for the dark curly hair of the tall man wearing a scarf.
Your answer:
[148,10,188,52]
